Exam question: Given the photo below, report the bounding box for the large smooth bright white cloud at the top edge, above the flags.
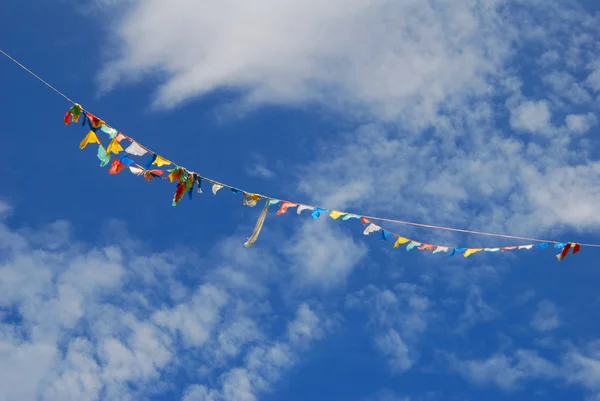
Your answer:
[101,0,511,124]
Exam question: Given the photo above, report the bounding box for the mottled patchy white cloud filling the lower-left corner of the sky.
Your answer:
[0,211,331,401]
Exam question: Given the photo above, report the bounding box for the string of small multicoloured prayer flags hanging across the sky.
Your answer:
[64,103,581,261]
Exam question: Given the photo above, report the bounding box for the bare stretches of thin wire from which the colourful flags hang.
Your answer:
[0,49,600,248]
